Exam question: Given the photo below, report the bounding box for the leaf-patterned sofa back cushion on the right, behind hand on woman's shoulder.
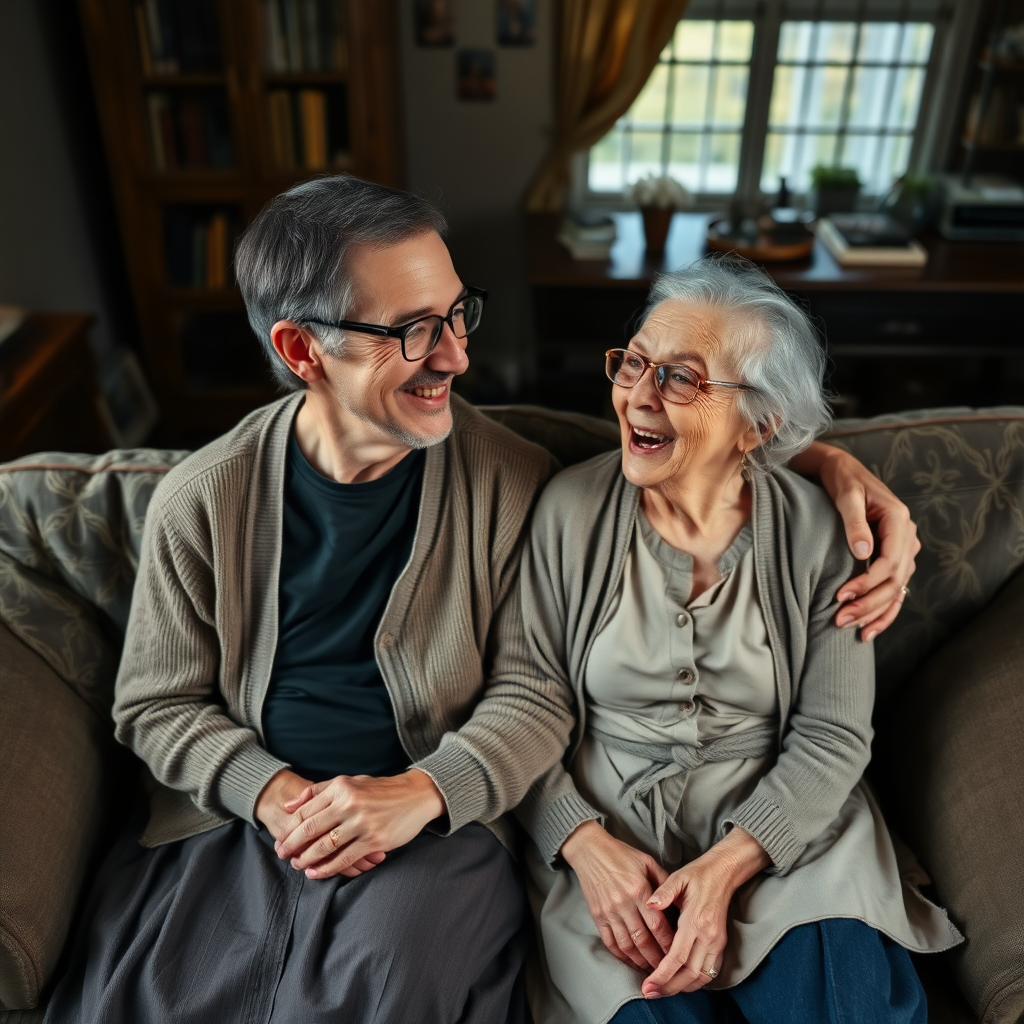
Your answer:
[825,407,1024,711]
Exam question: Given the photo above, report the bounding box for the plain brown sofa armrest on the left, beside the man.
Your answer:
[0,624,114,1007]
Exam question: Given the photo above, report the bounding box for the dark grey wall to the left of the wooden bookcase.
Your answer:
[0,0,133,358]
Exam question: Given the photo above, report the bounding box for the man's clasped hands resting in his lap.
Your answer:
[256,768,446,879]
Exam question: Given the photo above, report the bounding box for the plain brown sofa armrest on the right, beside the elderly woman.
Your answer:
[874,571,1024,1024]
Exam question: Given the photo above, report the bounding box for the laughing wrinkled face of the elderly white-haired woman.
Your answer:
[611,302,759,488]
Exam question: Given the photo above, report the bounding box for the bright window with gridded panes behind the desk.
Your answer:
[578,0,963,201]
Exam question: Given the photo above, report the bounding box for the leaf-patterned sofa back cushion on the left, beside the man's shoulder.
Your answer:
[0,449,187,717]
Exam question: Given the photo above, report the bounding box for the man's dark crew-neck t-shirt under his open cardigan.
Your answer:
[263,430,424,781]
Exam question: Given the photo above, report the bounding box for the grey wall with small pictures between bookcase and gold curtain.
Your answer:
[397,0,554,401]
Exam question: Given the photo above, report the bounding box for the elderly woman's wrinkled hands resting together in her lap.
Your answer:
[561,821,770,998]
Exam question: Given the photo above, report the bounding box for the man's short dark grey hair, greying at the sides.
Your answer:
[234,174,447,391]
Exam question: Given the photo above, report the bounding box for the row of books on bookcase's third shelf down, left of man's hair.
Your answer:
[164,207,238,290]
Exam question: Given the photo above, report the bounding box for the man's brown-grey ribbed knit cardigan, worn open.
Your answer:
[114,395,571,846]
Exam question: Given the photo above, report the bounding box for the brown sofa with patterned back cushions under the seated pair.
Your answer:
[0,406,1024,1024]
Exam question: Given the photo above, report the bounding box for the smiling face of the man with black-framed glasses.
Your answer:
[317,231,469,447]
